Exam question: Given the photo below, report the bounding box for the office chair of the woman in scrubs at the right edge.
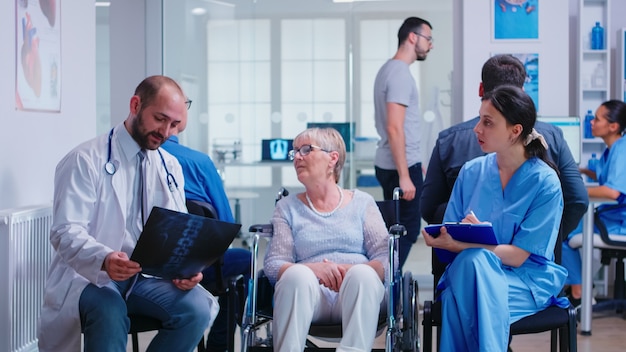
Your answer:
[569,204,626,319]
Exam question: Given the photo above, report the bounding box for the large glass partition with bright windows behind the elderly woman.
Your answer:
[162,0,452,226]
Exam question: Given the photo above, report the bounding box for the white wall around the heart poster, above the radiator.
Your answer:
[0,0,96,209]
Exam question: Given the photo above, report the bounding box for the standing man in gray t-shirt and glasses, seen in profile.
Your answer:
[374,17,433,266]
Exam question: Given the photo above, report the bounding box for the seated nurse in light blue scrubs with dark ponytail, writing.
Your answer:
[422,86,569,352]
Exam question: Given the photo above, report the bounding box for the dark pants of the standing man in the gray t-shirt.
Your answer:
[375,163,424,269]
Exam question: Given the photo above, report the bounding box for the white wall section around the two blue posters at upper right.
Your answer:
[455,0,576,120]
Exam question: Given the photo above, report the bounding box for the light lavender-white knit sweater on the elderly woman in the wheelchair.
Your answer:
[263,190,389,284]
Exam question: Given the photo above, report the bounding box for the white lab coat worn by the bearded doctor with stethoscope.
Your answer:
[38,124,193,352]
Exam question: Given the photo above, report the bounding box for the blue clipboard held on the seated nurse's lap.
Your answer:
[424,222,498,263]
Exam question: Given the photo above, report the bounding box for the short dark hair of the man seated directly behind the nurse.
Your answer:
[482,54,526,94]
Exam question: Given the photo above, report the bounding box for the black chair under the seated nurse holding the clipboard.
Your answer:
[422,227,577,352]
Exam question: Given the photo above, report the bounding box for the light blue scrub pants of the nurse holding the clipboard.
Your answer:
[438,248,551,352]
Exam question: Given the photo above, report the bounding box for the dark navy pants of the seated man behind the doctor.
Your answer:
[201,248,251,352]
